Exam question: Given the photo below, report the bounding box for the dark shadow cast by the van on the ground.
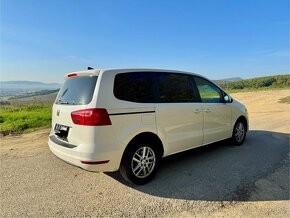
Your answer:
[106,130,289,201]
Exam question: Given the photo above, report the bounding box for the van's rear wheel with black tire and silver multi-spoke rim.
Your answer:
[120,139,161,185]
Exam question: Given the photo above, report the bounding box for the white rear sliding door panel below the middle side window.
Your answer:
[156,103,203,156]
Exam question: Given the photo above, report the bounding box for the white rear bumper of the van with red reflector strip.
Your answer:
[48,136,122,172]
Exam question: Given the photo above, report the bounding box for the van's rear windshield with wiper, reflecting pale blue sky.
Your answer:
[55,76,98,105]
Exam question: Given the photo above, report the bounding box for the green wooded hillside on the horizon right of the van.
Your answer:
[219,74,290,92]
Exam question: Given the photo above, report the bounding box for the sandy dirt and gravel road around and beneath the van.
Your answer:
[0,90,290,217]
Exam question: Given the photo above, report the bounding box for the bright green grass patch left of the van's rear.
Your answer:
[0,103,52,135]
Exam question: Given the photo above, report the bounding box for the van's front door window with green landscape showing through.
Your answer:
[195,77,223,103]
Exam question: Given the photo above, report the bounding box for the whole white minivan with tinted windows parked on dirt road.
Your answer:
[48,69,249,184]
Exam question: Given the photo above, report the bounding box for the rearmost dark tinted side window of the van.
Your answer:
[114,72,154,103]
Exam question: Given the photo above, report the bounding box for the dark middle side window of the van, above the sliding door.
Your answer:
[156,72,196,103]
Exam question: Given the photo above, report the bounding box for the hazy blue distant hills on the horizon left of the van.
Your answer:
[0,81,61,96]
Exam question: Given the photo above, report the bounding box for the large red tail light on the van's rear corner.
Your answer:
[71,108,112,126]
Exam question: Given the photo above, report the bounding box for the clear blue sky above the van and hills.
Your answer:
[0,0,289,83]
